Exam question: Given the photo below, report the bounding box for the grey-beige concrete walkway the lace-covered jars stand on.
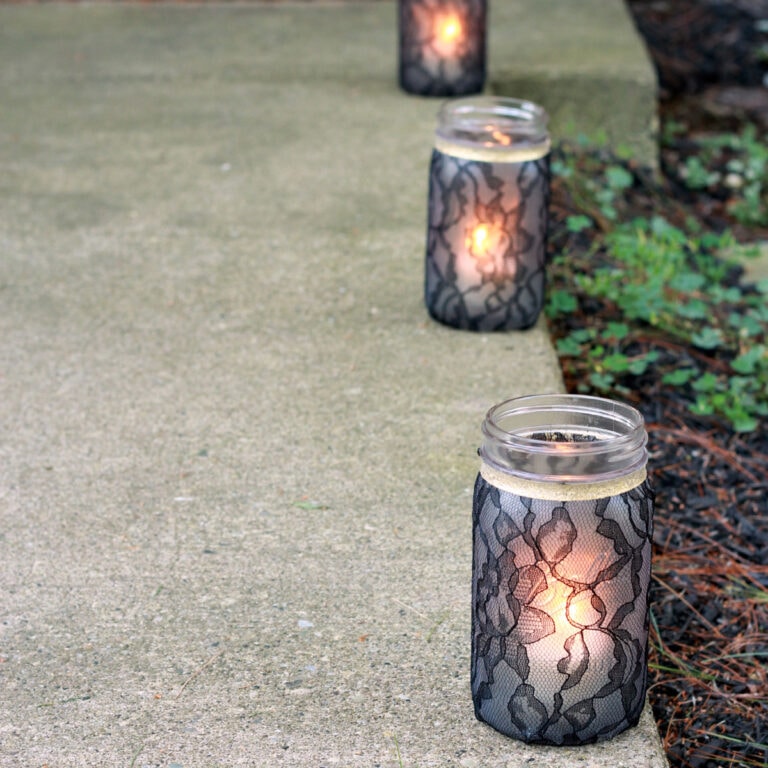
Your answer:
[0,0,665,768]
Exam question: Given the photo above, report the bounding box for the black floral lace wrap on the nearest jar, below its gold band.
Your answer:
[471,475,653,745]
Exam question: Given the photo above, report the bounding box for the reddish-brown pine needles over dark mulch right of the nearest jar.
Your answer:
[648,414,768,768]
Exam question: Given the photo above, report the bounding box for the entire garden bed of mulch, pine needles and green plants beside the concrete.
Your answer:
[546,0,768,768]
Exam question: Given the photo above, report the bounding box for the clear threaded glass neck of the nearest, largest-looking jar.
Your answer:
[479,395,648,484]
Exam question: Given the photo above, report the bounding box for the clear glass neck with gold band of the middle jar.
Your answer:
[435,96,551,162]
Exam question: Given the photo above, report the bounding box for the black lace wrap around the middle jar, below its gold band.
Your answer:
[425,149,549,331]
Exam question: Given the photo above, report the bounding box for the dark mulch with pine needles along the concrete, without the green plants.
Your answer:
[550,0,768,768]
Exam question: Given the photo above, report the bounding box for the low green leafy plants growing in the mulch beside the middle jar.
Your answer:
[546,148,768,432]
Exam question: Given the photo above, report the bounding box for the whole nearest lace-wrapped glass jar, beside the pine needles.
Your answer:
[471,395,653,745]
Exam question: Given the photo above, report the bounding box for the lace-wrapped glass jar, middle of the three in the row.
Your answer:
[424,96,551,331]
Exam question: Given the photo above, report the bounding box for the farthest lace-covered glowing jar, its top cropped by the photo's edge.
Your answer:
[398,0,486,96]
